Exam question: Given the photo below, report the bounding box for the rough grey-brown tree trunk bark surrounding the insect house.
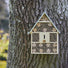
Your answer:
[7,0,68,68]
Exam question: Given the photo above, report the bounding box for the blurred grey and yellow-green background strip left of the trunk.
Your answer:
[0,0,9,68]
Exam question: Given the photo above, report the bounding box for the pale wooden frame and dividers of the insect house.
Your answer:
[28,12,60,54]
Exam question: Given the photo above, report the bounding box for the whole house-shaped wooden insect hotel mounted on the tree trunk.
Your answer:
[29,12,60,54]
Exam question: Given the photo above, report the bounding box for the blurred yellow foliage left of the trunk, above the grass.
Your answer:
[0,30,9,60]
